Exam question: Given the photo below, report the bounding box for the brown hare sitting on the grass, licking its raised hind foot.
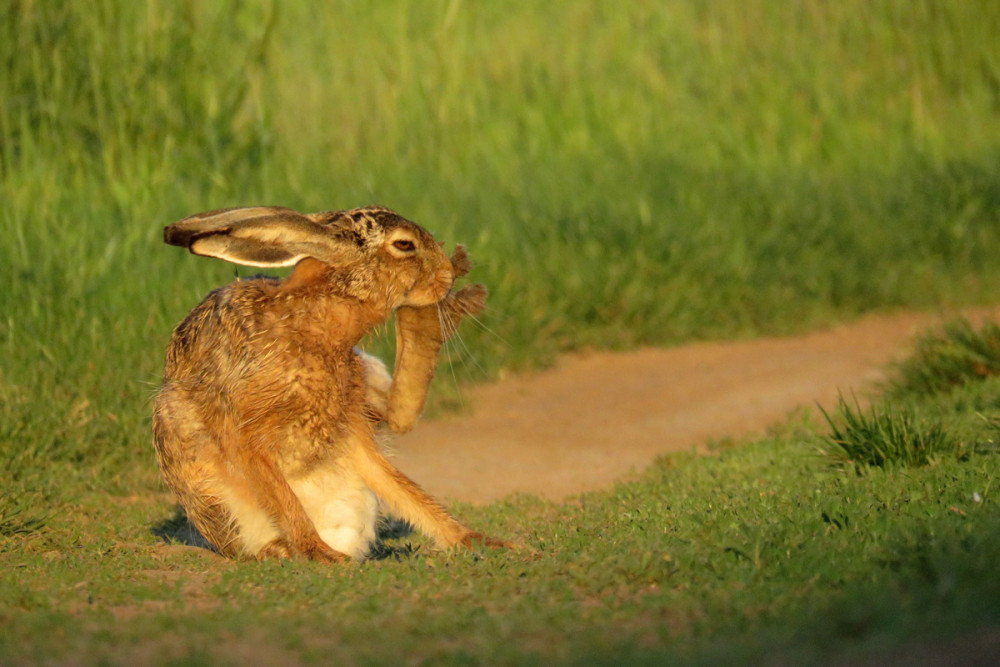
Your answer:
[153,207,506,562]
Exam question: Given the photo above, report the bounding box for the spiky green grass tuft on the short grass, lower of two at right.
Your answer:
[820,396,968,472]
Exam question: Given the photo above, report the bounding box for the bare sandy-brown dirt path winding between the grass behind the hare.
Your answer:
[390,309,1000,503]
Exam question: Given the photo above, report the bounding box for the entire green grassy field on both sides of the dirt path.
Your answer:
[0,0,1000,662]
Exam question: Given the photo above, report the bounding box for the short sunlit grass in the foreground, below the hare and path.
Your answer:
[0,326,1000,664]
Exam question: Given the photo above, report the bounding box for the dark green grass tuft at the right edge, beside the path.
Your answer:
[889,319,1000,398]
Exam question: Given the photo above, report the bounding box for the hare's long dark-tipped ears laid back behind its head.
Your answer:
[163,206,357,267]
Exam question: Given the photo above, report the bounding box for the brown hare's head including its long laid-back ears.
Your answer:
[163,206,455,309]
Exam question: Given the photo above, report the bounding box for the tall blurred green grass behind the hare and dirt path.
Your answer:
[0,0,1000,508]
